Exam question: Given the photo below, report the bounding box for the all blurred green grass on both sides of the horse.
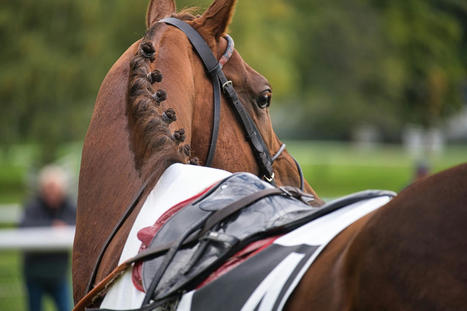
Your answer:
[0,141,467,311]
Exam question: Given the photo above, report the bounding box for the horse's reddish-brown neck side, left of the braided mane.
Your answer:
[73,44,142,299]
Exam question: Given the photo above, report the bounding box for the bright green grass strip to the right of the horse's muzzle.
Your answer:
[287,141,467,198]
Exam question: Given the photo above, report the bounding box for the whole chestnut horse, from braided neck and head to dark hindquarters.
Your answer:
[73,0,467,310]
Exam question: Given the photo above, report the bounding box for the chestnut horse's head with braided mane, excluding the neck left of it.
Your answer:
[127,0,313,199]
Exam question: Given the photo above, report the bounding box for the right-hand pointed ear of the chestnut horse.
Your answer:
[196,0,237,38]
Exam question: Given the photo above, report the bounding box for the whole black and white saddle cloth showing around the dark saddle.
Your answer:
[101,164,392,311]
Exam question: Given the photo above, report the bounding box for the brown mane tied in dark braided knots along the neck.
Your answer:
[127,24,198,174]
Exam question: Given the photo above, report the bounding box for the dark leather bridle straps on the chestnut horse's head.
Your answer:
[160,17,303,190]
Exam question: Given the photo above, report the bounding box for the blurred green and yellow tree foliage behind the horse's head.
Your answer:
[0,0,467,162]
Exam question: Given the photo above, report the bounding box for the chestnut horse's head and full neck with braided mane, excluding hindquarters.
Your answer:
[73,0,322,300]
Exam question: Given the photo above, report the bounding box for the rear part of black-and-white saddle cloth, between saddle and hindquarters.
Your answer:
[177,195,392,311]
